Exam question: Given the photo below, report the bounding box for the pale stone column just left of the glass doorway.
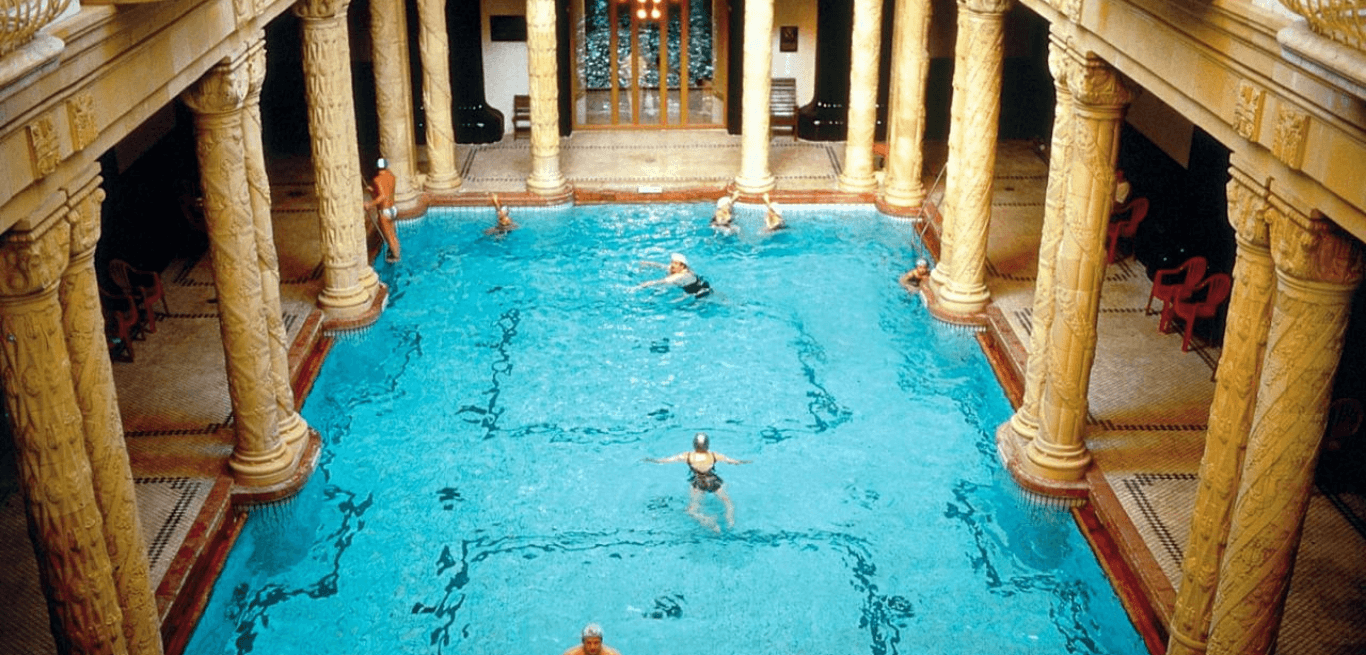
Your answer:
[526,0,568,197]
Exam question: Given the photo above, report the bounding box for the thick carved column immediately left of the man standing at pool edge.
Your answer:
[294,0,380,319]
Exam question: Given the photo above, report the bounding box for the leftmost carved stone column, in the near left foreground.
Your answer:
[0,207,128,655]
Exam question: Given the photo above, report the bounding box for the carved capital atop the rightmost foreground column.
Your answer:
[1268,201,1362,287]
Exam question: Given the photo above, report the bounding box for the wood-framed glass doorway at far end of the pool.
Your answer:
[574,0,725,128]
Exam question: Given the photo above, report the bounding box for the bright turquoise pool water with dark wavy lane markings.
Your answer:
[178,203,1146,655]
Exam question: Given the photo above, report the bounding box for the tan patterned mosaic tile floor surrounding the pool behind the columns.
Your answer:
[0,130,1366,655]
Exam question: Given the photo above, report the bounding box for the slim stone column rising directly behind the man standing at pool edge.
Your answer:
[370,0,418,207]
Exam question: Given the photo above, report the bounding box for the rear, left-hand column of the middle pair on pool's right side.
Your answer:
[997,35,1074,455]
